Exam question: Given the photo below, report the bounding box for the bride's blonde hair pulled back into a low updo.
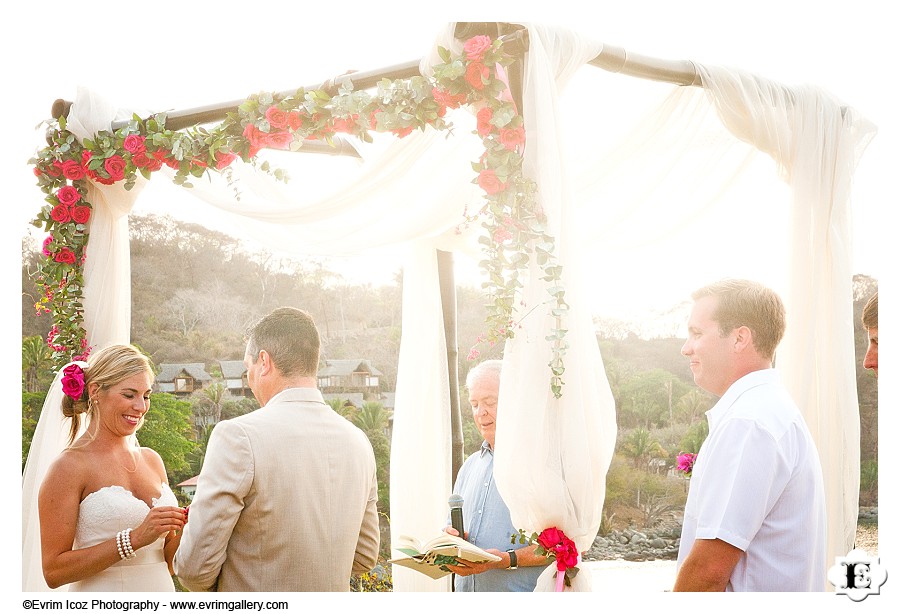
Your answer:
[62,344,154,445]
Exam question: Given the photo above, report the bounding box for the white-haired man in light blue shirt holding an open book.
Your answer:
[445,360,548,592]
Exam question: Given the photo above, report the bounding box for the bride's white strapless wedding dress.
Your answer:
[69,483,178,592]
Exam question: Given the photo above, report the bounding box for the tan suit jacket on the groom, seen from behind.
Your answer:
[174,388,379,591]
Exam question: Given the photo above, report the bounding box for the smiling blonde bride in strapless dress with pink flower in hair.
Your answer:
[38,345,187,591]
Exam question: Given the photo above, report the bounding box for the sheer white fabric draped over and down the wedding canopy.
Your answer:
[23,24,874,591]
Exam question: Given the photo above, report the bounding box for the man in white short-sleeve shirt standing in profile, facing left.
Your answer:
[674,280,826,591]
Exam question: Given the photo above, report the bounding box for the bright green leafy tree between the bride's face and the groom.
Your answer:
[138,393,197,476]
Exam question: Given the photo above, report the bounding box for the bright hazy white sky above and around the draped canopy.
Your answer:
[8,0,900,318]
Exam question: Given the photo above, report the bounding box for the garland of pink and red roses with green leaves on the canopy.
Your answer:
[30,36,568,397]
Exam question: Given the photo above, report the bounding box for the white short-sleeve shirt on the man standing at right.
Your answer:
[678,369,826,591]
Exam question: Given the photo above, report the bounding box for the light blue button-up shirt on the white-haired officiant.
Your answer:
[447,441,544,592]
